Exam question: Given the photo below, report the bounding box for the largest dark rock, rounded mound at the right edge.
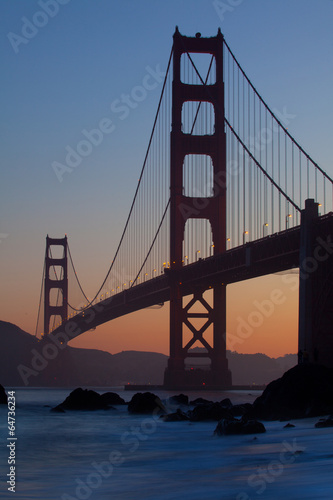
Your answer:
[249,363,333,420]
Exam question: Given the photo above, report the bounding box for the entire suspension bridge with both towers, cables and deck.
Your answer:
[36,28,333,388]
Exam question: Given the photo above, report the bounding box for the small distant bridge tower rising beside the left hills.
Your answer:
[44,236,68,335]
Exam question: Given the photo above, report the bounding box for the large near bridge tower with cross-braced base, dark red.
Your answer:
[164,28,231,388]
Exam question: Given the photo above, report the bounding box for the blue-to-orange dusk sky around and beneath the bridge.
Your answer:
[0,0,333,356]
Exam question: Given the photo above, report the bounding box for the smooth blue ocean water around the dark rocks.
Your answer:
[0,388,333,500]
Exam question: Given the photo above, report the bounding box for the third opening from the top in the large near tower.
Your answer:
[183,154,214,198]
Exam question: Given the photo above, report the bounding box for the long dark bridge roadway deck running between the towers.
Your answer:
[52,212,333,338]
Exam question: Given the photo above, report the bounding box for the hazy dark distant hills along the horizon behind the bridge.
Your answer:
[0,321,297,387]
